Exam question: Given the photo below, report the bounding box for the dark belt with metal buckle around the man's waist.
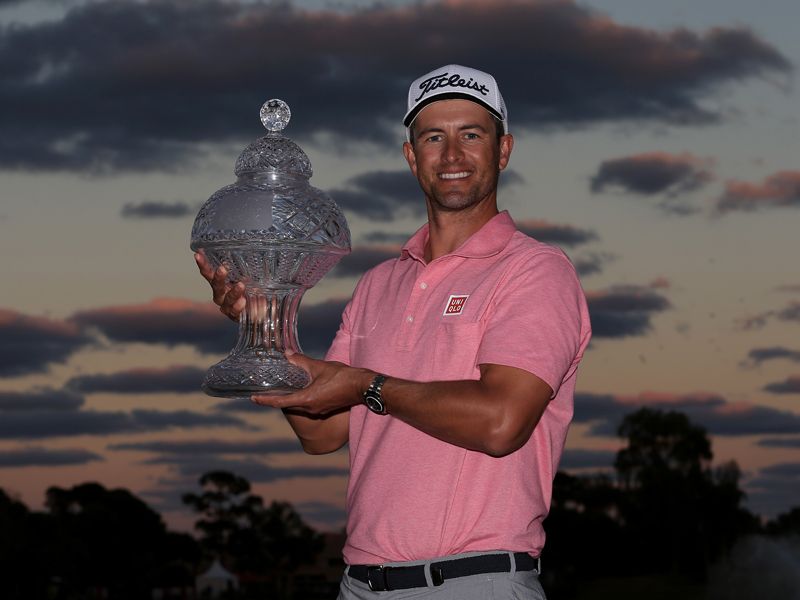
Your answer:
[347,552,538,592]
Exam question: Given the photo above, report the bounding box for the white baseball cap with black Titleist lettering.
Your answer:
[403,65,508,135]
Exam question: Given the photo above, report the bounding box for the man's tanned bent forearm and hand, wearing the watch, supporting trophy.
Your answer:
[253,354,552,456]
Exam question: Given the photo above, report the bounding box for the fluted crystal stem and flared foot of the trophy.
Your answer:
[203,287,310,398]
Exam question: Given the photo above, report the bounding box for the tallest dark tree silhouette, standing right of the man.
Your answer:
[614,408,756,579]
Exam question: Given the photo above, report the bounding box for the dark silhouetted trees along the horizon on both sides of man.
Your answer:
[0,409,800,600]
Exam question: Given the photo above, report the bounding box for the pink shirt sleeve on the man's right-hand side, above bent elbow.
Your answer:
[477,248,590,396]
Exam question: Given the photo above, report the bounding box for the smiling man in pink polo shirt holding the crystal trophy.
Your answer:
[198,65,590,600]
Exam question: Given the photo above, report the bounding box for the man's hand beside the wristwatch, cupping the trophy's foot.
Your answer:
[252,350,375,417]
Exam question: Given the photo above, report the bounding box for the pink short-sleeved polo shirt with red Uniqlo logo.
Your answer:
[327,212,590,564]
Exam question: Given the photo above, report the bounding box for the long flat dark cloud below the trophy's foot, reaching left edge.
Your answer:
[0,410,251,439]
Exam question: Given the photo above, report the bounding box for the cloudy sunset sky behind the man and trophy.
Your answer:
[0,0,800,529]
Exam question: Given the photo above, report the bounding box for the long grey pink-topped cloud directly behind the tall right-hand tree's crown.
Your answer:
[574,392,800,436]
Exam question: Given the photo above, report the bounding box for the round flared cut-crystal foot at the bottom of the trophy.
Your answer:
[202,353,311,400]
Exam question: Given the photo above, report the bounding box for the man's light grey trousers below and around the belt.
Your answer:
[338,552,545,600]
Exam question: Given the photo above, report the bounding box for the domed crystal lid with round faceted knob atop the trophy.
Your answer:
[234,98,313,179]
